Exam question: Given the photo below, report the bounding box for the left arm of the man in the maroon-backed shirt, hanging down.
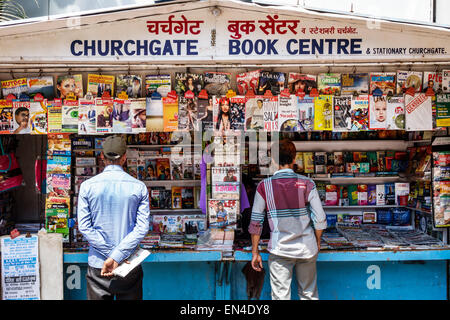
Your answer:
[248,186,266,271]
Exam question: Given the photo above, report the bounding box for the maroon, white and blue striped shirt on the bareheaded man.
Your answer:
[249,169,327,259]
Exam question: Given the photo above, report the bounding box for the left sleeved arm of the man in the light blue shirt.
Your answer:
[77,183,113,257]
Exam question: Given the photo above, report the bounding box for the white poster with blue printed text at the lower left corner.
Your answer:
[1,235,41,300]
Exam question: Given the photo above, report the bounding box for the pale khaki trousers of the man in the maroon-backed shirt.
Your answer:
[268,254,319,300]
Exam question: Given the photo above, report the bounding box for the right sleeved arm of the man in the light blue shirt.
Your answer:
[109,186,150,264]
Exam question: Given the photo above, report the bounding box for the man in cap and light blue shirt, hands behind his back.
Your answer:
[77,136,150,300]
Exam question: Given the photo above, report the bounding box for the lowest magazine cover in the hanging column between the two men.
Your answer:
[208,199,239,229]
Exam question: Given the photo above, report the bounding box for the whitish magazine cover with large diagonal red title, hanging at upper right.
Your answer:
[405,93,433,131]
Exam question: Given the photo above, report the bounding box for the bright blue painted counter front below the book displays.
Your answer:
[64,249,450,300]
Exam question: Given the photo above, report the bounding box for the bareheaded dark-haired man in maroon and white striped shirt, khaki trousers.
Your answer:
[249,140,327,300]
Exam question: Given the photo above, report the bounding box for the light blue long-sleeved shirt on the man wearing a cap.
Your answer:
[77,165,150,268]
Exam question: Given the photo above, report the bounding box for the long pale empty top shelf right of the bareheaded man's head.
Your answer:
[292,140,408,152]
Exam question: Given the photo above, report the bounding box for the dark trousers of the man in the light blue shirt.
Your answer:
[86,266,144,300]
